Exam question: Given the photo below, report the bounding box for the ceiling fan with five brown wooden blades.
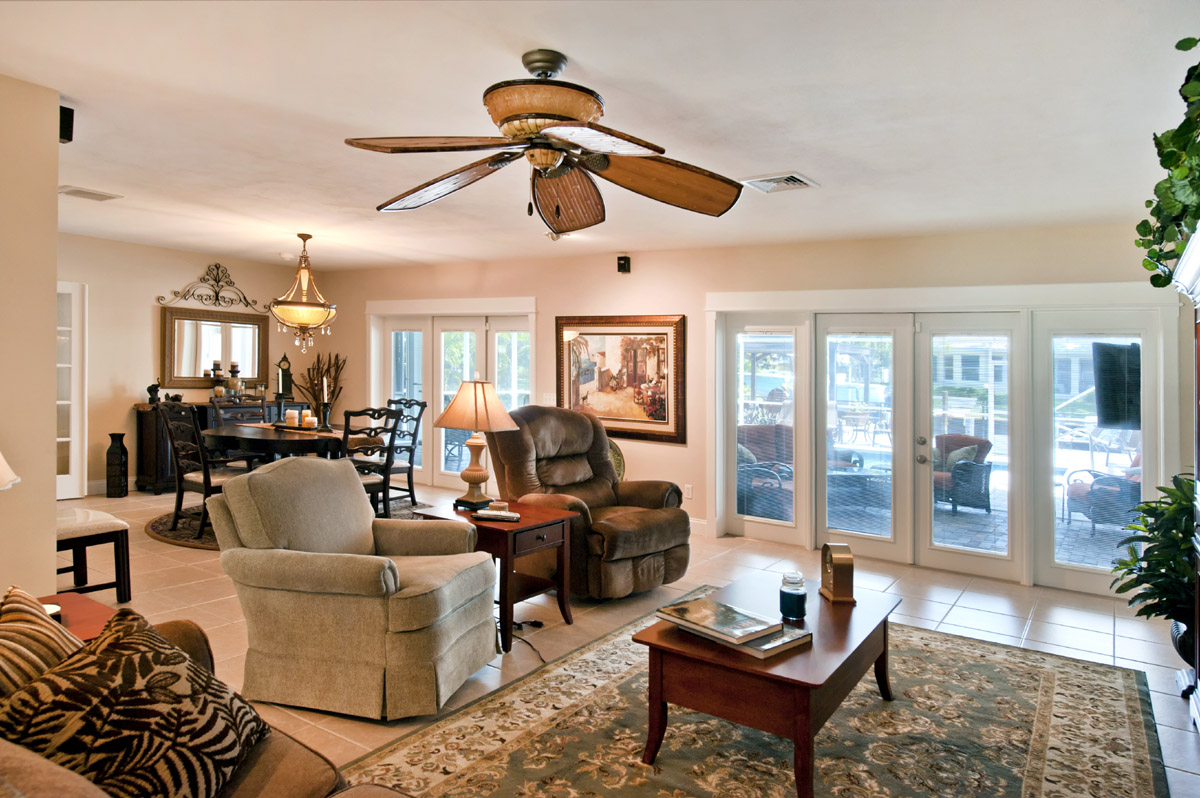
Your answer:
[346,49,742,234]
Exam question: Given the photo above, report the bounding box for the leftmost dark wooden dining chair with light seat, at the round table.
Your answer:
[157,402,254,539]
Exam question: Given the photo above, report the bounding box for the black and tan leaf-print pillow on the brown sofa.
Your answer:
[0,610,270,798]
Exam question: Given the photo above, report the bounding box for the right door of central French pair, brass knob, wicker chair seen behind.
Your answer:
[914,313,1026,581]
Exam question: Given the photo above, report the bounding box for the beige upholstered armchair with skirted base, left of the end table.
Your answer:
[208,457,498,719]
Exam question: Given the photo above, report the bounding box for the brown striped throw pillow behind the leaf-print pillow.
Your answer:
[0,586,83,700]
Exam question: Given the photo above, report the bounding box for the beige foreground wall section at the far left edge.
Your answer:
[0,76,59,595]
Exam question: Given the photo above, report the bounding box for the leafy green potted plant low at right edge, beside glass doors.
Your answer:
[1111,474,1196,634]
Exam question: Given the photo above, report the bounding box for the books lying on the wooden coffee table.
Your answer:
[655,599,812,660]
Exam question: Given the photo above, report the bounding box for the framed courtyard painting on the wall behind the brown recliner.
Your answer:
[554,316,688,443]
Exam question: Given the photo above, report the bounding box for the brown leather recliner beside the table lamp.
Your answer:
[487,404,690,599]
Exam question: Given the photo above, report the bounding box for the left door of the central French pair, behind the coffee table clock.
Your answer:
[814,313,913,563]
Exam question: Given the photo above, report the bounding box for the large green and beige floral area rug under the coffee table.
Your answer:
[343,597,1168,798]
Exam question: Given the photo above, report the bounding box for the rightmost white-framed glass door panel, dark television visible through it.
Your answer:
[1031,311,1164,593]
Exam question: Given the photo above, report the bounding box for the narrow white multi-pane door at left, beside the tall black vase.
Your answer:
[55,282,87,499]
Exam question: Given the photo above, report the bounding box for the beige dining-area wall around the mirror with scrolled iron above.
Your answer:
[58,234,301,493]
